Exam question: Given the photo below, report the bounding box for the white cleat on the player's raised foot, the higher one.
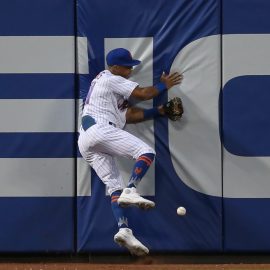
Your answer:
[117,187,155,210]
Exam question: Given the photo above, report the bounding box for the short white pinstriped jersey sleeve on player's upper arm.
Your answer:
[110,76,139,98]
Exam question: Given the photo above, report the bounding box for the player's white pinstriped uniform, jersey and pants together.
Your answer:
[78,70,155,194]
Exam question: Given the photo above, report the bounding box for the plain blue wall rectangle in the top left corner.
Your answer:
[0,0,75,36]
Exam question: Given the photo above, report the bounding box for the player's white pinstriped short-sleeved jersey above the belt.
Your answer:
[83,70,138,129]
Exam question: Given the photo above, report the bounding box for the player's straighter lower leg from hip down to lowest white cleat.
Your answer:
[78,125,149,256]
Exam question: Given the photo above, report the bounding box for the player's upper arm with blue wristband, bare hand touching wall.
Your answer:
[131,72,183,100]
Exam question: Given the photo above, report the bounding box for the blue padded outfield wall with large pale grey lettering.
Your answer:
[0,0,270,253]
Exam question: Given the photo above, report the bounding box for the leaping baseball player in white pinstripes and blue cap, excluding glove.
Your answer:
[78,48,182,256]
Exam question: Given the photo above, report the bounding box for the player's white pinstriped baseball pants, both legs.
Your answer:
[78,124,155,195]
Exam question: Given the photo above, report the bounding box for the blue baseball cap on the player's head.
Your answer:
[106,48,141,67]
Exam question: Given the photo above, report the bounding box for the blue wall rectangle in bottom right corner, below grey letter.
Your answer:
[224,198,270,252]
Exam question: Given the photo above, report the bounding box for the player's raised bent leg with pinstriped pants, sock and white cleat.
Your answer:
[79,125,155,209]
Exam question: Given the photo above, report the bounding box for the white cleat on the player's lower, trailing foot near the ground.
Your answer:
[114,228,149,256]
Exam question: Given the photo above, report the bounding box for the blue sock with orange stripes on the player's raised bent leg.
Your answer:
[128,153,155,188]
